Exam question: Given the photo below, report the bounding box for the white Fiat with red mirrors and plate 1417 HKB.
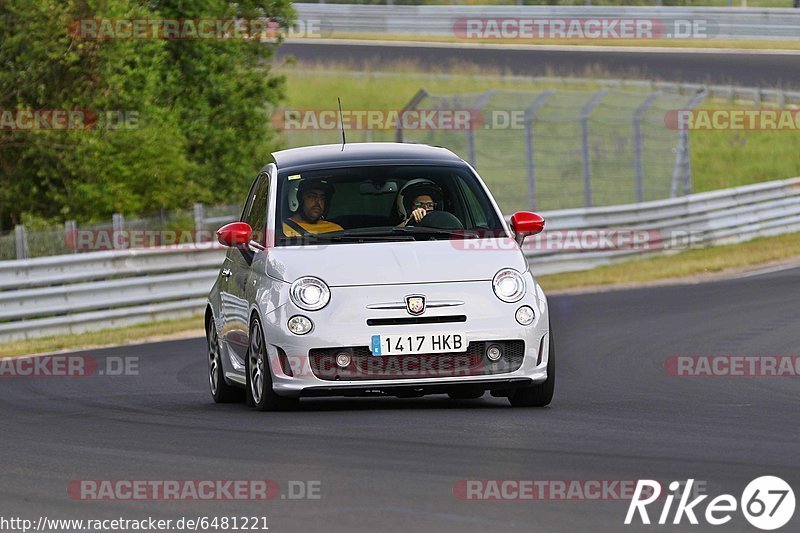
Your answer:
[205,143,555,410]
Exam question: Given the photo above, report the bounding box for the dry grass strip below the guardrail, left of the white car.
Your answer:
[0,315,203,357]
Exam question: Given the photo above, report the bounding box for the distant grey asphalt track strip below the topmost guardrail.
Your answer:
[278,41,800,89]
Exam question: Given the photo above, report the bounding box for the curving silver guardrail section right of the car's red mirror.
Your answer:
[525,178,800,275]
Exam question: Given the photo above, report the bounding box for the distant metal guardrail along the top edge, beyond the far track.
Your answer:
[294,3,800,43]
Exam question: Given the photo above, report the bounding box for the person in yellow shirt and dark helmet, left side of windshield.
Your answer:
[283,179,344,237]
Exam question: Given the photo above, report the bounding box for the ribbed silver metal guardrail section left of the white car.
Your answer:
[0,245,225,342]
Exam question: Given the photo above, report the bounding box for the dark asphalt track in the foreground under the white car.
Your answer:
[0,269,800,532]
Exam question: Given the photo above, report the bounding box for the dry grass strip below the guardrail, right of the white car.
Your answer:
[533,233,800,291]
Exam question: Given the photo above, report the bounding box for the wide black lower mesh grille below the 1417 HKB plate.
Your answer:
[308,340,525,381]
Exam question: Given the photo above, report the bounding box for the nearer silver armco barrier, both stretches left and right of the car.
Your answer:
[0,178,800,344]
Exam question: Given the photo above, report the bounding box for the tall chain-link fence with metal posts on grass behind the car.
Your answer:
[284,88,706,212]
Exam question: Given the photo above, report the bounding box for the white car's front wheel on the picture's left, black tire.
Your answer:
[245,318,300,411]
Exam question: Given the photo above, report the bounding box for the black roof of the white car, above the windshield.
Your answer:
[272,142,464,170]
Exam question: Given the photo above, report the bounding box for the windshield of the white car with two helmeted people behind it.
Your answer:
[275,165,506,246]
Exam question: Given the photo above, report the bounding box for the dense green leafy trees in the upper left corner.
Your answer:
[0,0,293,228]
